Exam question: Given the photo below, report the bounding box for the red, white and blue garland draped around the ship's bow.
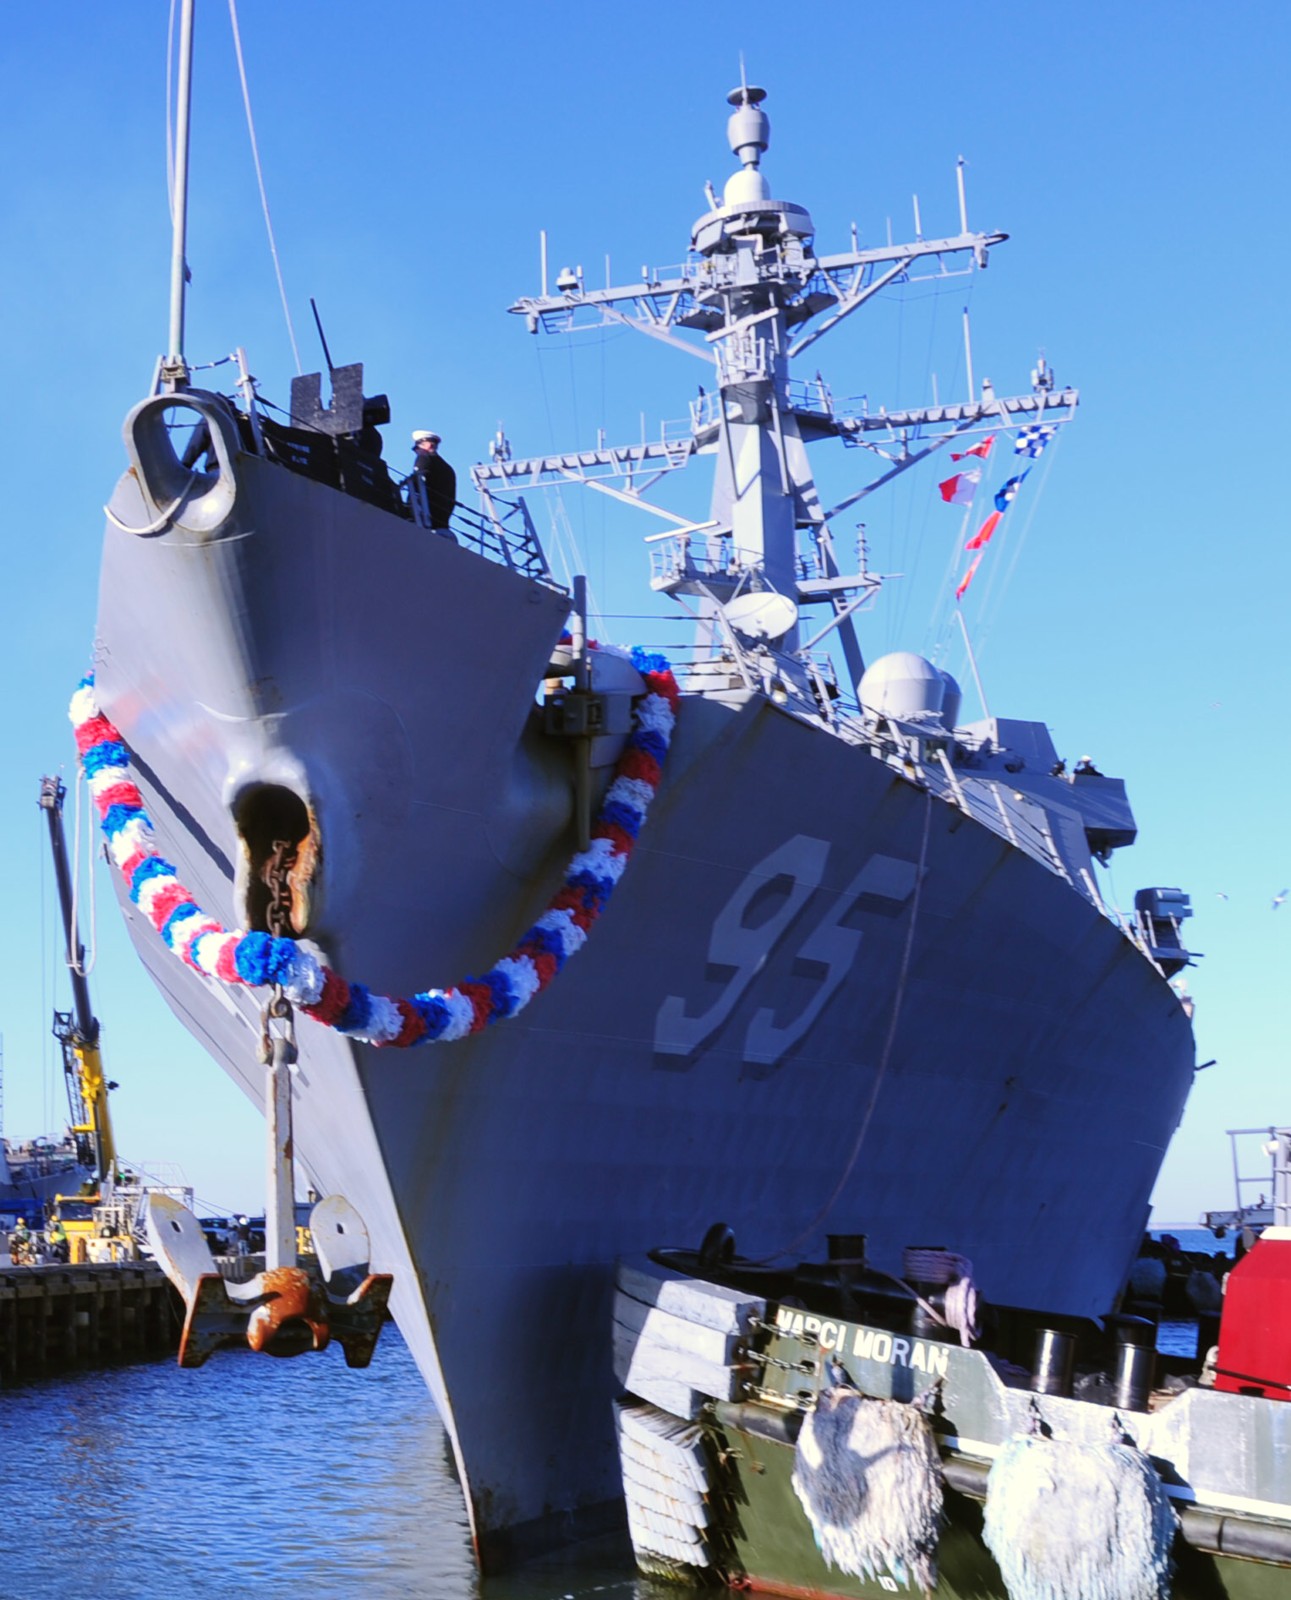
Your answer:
[67,646,678,1048]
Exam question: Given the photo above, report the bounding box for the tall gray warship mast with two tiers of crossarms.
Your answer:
[472,82,1078,688]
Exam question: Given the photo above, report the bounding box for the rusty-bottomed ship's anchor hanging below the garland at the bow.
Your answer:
[147,992,394,1366]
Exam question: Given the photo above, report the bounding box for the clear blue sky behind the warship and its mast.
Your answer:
[0,0,1291,1221]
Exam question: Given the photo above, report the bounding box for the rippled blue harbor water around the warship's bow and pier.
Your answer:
[0,1230,1232,1600]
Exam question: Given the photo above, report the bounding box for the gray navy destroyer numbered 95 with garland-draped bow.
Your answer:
[74,12,1193,1550]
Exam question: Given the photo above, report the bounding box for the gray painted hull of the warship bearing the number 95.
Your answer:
[96,435,1193,1539]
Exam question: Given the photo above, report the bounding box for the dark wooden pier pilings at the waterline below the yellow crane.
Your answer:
[0,1261,184,1384]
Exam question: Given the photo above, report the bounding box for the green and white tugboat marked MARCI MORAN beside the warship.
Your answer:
[613,1226,1291,1600]
